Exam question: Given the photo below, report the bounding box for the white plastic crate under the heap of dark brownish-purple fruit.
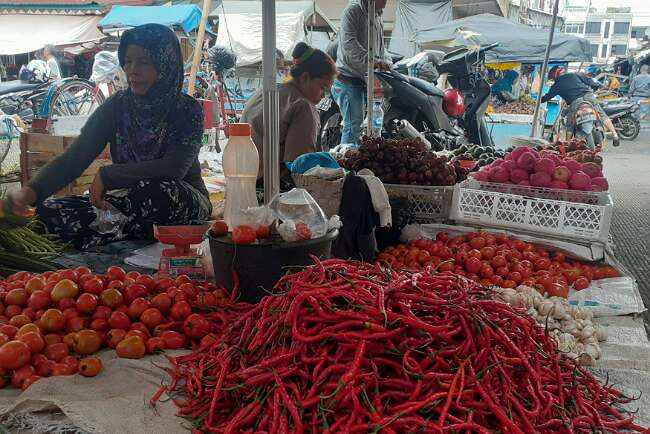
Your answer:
[384,184,454,223]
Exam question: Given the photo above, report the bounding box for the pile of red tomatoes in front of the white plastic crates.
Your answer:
[377,231,619,297]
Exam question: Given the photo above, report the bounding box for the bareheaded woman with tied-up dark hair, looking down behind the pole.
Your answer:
[241,42,336,178]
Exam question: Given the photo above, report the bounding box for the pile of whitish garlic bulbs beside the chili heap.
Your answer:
[494,285,607,365]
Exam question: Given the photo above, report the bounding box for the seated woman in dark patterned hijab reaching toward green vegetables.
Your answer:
[6,24,212,248]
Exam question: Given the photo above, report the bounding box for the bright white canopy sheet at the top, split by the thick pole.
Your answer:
[210,1,334,66]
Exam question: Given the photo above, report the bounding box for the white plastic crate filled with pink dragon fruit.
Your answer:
[451,180,613,243]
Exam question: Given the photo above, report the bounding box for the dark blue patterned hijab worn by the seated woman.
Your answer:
[111,24,183,164]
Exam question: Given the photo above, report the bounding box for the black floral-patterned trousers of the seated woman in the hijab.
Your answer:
[36,180,212,250]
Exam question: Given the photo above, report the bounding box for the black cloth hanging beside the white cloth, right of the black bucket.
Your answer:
[332,174,379,262]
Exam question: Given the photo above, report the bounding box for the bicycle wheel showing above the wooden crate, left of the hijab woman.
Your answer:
[48,80,105,122]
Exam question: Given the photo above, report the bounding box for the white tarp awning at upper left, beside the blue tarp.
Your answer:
[0,14,105,55]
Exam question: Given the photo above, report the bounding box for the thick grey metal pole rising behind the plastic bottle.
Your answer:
[262,0,280,204]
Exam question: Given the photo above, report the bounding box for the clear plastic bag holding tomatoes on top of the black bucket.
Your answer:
[269,188,328,241]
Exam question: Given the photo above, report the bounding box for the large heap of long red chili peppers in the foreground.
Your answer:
[152,260,644,434]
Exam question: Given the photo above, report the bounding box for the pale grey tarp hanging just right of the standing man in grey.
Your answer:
[388,0,453,57]
